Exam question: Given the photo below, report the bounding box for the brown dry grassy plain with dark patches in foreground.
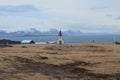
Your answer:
[0,43,120,80]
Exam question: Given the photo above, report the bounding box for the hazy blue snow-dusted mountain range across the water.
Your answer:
[0,28,82,36]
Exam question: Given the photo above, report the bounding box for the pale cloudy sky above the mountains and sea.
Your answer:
[0,0,120,33]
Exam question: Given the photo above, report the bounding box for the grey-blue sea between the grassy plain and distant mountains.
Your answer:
[0,34,120,44]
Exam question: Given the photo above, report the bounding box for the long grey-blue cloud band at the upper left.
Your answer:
[0,5,38,12]
